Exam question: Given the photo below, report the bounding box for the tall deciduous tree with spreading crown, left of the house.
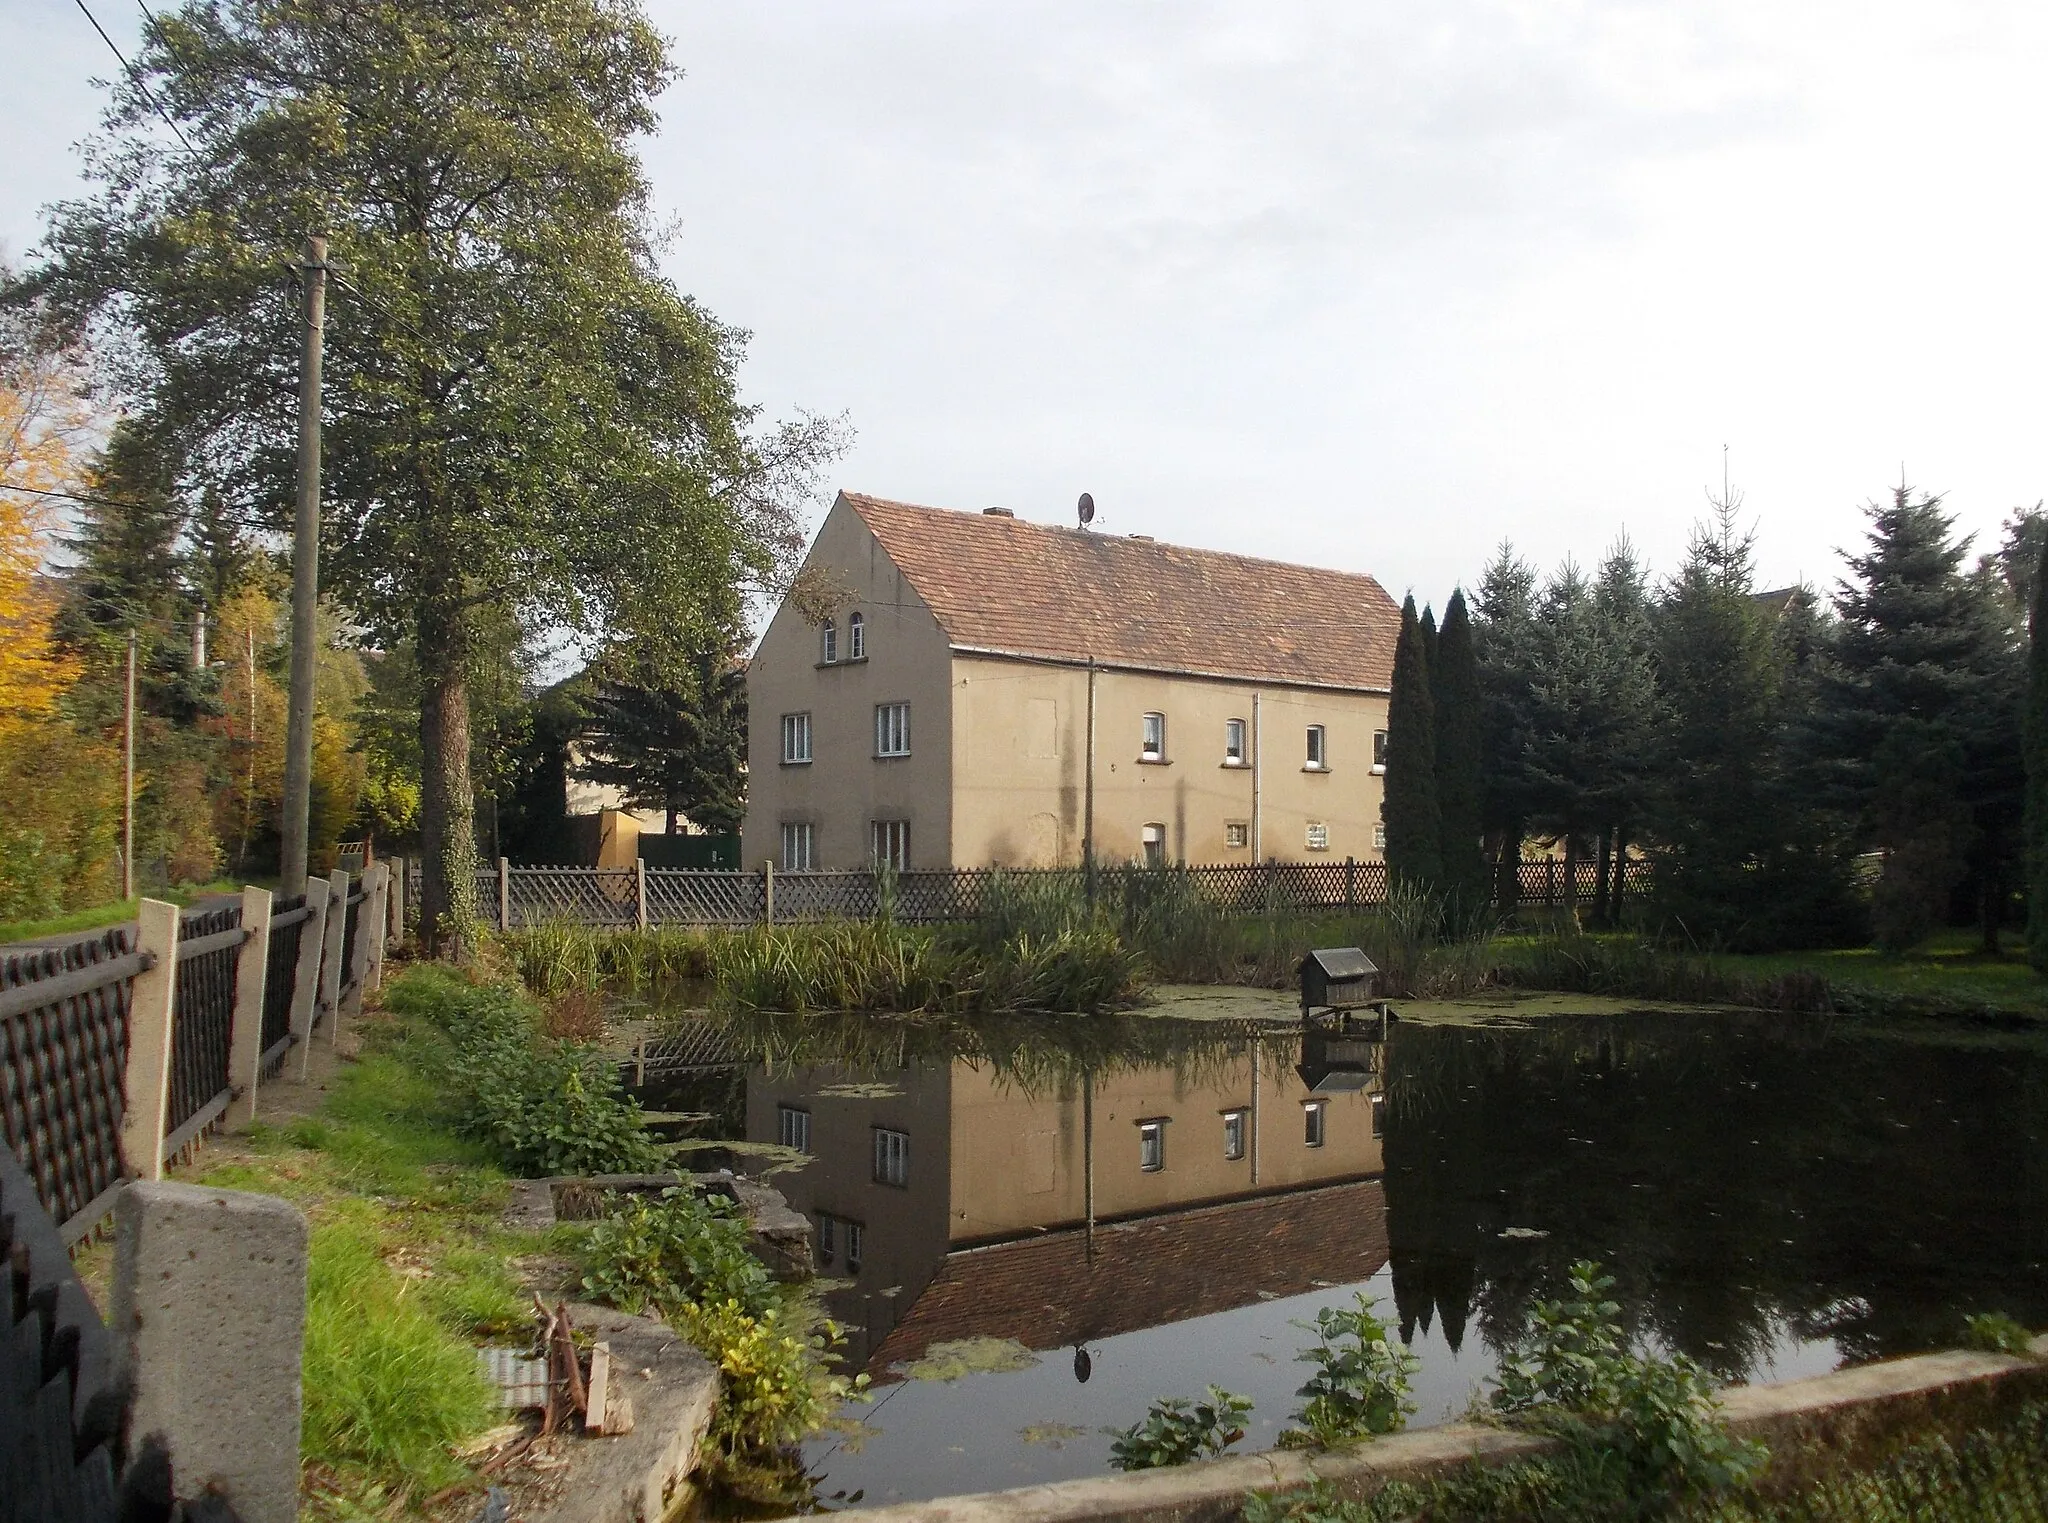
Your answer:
[33,0,836,952]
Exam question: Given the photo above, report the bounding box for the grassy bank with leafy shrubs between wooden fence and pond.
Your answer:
[199,966,840,1519]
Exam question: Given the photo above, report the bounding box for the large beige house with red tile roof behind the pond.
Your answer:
[743,491,1399,870]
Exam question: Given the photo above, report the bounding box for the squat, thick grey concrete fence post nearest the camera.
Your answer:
[109,1181,307,1523]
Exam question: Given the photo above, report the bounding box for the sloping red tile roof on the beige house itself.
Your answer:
[840,491,1401,692]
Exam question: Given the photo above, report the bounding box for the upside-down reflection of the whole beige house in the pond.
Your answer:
[745,1028,1386,1382]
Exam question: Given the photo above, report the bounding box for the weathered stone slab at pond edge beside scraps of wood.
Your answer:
[530,1302,719,1523]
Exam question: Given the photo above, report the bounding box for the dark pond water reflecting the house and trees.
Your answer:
[643,1011,2048,1507]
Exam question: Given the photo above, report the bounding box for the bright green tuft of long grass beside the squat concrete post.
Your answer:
[303,1222,498,1490]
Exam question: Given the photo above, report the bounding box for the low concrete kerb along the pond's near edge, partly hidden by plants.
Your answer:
[843,1337,2048,1523]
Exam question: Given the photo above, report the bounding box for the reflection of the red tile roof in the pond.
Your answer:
[866,1179,1386,1382]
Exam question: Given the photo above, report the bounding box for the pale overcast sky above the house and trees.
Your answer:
[0,0,2048,606]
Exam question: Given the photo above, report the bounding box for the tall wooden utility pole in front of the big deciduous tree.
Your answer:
[281,237,328,895]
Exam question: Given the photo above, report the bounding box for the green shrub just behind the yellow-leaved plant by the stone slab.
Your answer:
[584,1189,780,1316]
